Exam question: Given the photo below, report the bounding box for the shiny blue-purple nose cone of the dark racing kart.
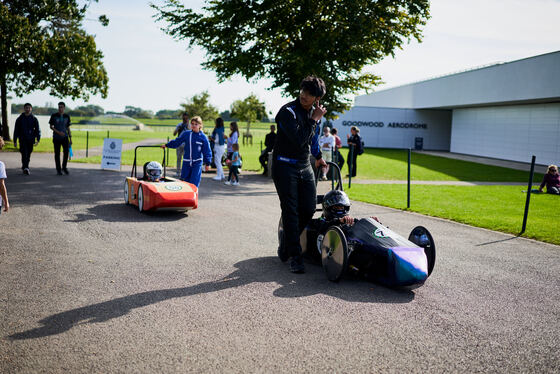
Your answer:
[390,247,428,285]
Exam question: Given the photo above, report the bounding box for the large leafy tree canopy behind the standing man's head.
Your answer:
[151,0,429,118]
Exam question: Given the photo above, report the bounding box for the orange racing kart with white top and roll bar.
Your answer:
[124,145,198,212]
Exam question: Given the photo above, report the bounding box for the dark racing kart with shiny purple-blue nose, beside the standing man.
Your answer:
[278,162,436,287]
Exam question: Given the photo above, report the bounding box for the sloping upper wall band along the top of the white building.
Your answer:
[355,51,560,109]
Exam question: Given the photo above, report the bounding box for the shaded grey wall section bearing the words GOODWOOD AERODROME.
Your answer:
[333,107,451,151]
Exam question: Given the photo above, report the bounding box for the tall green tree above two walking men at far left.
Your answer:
[0,0,108,139]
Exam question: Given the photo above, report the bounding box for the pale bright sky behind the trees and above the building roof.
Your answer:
[12,0,560,113]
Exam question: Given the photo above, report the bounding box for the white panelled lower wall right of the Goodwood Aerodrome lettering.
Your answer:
[451,103,560,165]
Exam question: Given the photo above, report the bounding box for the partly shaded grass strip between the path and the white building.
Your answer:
[341,149,543,182]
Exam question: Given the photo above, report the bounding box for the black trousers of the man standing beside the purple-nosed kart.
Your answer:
[272,160,317,256]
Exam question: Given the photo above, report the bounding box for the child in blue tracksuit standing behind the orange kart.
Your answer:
[163,116,212,187]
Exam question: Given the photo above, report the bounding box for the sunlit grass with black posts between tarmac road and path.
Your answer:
[345,184,560,244]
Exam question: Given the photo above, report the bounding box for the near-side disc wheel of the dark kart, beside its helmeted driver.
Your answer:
[321,226,348,282]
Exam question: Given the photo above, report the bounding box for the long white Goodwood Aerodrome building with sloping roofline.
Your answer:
[333,51,560,165]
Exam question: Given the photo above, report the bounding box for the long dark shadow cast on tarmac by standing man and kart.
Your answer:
[9,257,414,340]
